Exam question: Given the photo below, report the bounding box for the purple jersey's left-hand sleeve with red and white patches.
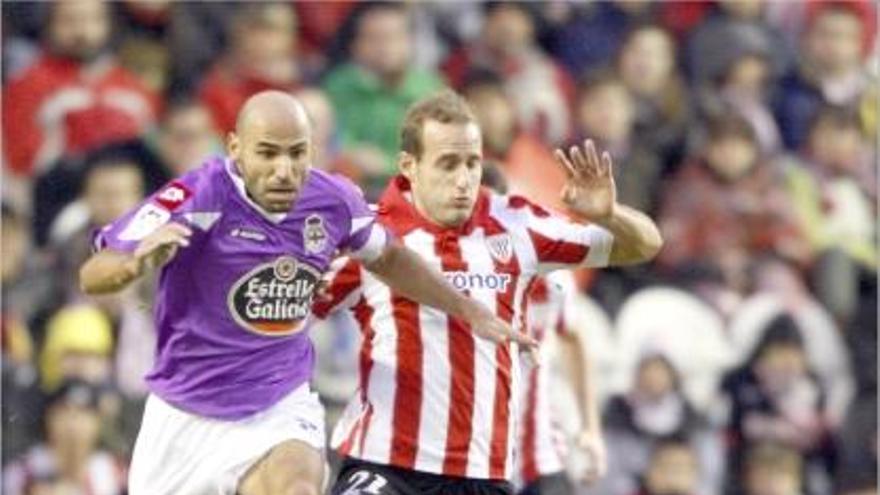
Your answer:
[92,177,200,253]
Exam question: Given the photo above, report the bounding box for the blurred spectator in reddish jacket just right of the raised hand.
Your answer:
[660,116,806,292]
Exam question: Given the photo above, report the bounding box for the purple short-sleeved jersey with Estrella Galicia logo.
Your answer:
[96,158,385,419]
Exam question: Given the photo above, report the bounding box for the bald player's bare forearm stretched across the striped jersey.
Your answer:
[364,243,536,348]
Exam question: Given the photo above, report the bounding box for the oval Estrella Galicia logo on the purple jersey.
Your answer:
[227,256,320,337]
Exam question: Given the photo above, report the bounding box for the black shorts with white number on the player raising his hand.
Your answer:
[330,457,513,495]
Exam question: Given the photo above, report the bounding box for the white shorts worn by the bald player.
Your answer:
[128,383,325,495]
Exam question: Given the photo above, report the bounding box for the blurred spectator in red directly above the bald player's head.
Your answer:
[199,3,303,135]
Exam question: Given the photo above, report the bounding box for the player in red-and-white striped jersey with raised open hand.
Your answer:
[315,92,662,495]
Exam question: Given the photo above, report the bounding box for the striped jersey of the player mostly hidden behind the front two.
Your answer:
[516,271,577,484]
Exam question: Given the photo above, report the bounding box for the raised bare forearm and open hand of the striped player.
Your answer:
[556,139,663,265]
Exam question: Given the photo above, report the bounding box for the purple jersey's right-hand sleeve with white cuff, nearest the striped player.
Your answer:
[339,179,388,263]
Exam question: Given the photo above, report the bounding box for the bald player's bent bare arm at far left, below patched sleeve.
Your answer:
[79,223,192,295]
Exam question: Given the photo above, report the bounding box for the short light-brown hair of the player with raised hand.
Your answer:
[400,89,477,158]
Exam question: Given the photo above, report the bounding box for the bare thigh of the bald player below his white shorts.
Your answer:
[238,440,324,495]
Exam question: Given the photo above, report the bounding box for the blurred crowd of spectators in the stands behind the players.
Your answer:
[2,0,878,495]
